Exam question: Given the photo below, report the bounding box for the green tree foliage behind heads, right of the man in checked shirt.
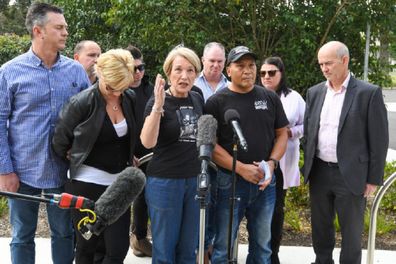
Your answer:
[2,0,396,91]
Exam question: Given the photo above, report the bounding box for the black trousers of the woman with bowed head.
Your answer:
[66,180,131,264]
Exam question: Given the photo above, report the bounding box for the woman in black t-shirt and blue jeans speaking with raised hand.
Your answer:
[140,46,204,264]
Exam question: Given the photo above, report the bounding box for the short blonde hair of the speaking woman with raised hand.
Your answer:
[163,46,201,79]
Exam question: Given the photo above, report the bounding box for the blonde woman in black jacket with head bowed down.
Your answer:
[52,49,138,264]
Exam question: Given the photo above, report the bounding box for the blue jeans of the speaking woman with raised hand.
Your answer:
[145,176,199,264]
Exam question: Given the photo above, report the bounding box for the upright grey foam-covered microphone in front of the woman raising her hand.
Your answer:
[197,115,217,193]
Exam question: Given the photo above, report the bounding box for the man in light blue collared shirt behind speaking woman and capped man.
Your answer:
[194,42,228,102]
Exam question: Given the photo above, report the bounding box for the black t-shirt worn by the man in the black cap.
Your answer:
[205,85,289,164]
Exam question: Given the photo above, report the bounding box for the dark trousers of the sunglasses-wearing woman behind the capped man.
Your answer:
[271,167,287,264]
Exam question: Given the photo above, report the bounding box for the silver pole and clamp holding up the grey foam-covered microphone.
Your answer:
[196,159,210,264]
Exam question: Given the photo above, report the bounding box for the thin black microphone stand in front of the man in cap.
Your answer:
[227,133,238,263]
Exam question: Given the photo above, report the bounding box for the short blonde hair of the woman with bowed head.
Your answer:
[95,49,135,92]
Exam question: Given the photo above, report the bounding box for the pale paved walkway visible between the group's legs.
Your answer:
[0,238,396,264]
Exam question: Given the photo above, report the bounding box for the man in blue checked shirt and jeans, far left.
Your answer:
[0,3,90,264]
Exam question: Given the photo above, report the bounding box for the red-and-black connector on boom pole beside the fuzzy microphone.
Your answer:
[43,193,95,209]
